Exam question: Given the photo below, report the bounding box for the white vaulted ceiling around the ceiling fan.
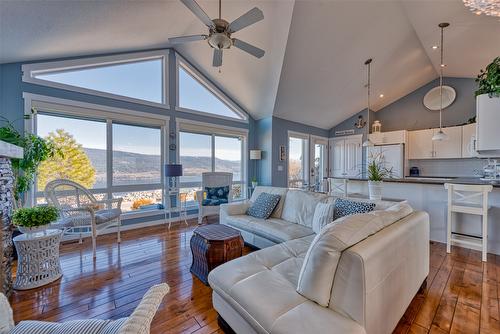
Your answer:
[0,0,500,129]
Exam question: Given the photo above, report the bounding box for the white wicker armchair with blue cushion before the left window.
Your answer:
[45,179,123,258]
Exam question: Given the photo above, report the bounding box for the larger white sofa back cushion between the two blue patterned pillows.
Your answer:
[281,190,328,228]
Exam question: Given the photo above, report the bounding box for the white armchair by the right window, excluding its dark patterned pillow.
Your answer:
[196,172,233,224]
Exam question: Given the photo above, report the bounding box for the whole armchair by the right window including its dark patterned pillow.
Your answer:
[196,172,233,224]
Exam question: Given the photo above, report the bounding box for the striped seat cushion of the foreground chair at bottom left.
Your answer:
[10,318,127,334]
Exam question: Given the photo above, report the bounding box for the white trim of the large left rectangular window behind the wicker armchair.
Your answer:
[23,93,170,219]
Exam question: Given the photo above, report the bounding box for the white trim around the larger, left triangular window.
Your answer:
[21,50,170,109]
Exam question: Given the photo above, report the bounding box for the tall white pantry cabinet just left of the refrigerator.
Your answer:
[330,135,362,177]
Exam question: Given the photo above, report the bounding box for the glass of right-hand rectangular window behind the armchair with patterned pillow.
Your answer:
[179,124,246,204]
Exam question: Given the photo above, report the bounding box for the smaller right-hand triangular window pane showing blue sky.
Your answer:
[178,66,245,120]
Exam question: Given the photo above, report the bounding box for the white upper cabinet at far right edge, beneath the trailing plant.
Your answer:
[476,94,500,152]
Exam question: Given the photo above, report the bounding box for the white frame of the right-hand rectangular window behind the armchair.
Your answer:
[175,118,249,206]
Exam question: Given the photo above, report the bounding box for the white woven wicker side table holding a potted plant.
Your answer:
[13,230,62,290]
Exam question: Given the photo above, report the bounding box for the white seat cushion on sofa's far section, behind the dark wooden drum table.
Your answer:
[224,215,314,243]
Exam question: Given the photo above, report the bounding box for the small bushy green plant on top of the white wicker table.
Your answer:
[12,206,59,233]
